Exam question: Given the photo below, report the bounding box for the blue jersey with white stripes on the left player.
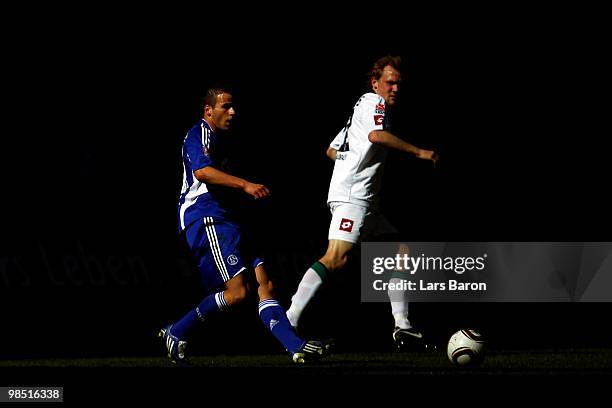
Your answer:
[178,119,226,232]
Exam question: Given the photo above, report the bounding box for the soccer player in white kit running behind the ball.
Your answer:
[287,56,438,348]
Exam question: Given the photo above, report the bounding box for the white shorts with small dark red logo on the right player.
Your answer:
[328,202,397,244]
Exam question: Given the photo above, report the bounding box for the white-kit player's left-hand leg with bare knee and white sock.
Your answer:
[287,239,354,327]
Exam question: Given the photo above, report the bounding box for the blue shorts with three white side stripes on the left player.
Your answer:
[185,217,262,290]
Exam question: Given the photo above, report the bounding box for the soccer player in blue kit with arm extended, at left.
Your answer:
[159,88,324,363]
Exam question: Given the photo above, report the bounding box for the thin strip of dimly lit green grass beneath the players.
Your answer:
[0,349,612,374]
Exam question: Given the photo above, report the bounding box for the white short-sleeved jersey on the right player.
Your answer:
[327,93,389,208]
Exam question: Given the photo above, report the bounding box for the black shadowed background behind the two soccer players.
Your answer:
[0,9,611,358]
